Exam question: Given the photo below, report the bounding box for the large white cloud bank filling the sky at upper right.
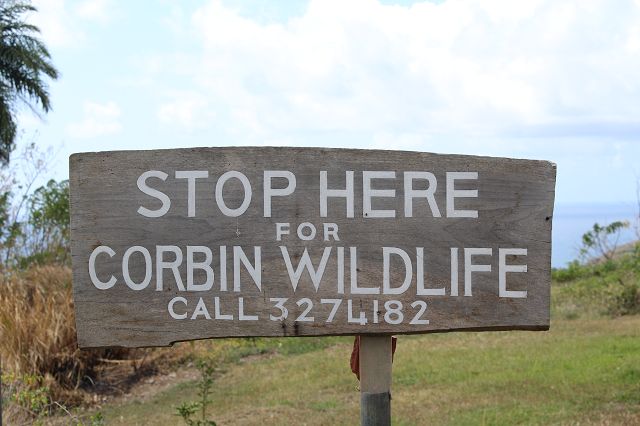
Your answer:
[142,0,640,147]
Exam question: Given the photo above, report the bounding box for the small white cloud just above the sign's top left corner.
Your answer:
[67,102,122,139]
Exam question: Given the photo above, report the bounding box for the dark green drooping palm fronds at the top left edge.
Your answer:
[0,0,58,164]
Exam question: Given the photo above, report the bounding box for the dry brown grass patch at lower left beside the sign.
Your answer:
[0,265,193,424]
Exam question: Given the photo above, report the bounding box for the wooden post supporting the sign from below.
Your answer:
[360,336,392,426]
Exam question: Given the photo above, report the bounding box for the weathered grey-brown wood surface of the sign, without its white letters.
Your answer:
[70,147,556,347]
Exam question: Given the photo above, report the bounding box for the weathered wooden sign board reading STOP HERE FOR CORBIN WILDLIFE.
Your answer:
[70,148,555,347]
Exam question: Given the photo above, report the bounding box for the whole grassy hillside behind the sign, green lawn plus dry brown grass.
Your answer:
[5,245,640,425]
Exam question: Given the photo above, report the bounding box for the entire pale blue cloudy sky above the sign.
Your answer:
[20,0,640,210]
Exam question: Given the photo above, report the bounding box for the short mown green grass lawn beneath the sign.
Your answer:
[91,315,640,425]
